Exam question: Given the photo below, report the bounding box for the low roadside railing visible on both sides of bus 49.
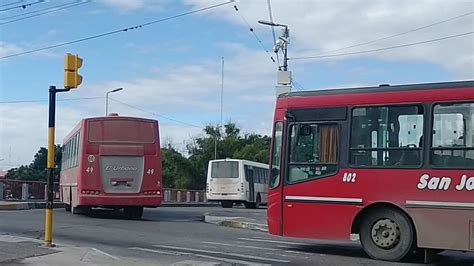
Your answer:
[0,179,207,203]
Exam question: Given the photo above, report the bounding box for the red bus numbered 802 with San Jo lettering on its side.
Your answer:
[267,81,474,261]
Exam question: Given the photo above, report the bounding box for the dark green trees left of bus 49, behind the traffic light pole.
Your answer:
[5,145,61,181]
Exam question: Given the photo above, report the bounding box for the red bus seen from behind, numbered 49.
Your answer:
[60,115,162,219]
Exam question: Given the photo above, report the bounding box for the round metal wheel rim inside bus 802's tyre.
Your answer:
[371,219,401,249]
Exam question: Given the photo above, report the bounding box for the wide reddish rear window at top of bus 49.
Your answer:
[88,119,157,143]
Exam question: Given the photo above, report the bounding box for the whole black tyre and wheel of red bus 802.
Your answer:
[360,208,416,261]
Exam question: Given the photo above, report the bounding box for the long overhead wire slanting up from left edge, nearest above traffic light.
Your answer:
[0,0,235,59]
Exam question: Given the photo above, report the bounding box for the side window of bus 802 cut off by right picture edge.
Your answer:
[431,103,474,168]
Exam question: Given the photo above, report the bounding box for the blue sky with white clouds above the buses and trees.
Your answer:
[0,0,474,169]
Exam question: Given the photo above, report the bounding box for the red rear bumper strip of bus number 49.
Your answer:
[78,195,161,207]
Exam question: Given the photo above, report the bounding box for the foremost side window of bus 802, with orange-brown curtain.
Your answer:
[288,124,338,183]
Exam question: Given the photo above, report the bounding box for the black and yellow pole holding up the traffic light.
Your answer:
[44,86,70,247]
